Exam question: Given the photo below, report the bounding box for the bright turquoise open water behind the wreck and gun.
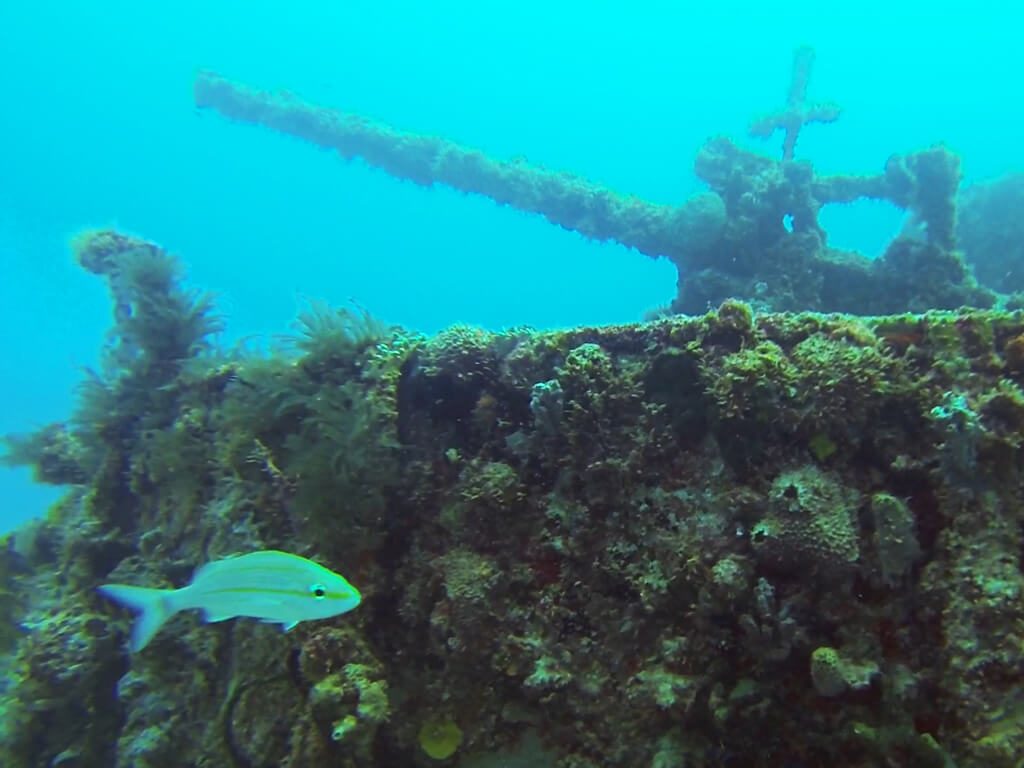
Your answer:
[0,0,1024,530]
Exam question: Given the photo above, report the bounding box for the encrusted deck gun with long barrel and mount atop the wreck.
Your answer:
[194,46,995,314]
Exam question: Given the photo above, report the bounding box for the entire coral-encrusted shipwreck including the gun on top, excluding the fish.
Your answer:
[0,50,1024,768]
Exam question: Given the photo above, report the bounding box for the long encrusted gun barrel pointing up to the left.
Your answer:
[195,72,722,268]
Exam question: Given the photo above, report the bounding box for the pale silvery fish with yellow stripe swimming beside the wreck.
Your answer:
[96,550,362,650]
